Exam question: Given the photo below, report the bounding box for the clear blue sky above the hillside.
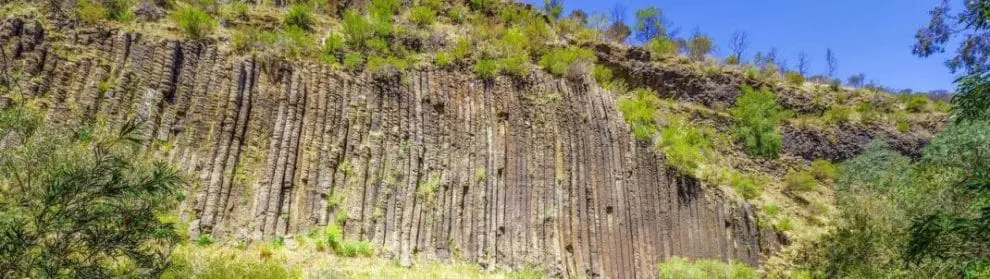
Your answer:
[524,0,960,91]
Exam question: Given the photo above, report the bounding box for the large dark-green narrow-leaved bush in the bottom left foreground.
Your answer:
[0,108,184,278]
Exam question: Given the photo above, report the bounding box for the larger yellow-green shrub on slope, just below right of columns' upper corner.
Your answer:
[657,116,712,175]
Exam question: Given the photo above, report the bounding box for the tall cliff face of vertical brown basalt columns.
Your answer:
[0,19,777,278]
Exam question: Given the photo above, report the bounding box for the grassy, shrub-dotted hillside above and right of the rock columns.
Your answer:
[0,0,945,276]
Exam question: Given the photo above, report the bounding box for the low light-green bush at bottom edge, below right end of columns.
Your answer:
[657,257,760,279]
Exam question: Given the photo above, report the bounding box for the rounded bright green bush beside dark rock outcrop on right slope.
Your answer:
[731,85,783,158]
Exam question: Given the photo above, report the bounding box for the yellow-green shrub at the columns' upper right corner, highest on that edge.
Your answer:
[618,88,660,140]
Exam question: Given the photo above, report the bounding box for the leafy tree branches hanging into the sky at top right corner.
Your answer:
[911,0,990,73]
